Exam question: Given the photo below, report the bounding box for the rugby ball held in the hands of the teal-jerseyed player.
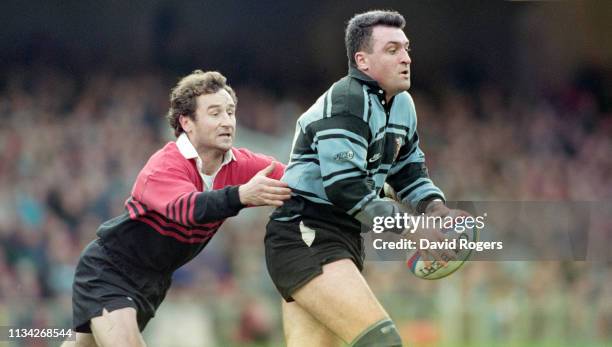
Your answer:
[406,219,479,280]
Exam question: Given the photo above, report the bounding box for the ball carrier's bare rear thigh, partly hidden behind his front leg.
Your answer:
[282,300,341,347]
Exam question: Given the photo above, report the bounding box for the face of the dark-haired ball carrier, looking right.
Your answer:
[356,26,412,96]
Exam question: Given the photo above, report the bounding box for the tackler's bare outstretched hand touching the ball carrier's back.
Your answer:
[238,162,291,206]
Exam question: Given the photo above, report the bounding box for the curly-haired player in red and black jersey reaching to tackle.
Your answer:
[64,70,291,347]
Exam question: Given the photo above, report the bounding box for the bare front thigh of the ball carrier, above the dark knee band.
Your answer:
[292,259,389,343]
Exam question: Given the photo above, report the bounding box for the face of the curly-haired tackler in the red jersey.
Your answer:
[183,89,236,153]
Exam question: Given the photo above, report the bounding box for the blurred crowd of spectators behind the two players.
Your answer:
[0,64,612,346]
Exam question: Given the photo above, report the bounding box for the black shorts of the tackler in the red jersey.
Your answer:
[72,239,171,333]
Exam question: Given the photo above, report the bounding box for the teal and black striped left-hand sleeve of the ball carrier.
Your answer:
[312,115,401,232]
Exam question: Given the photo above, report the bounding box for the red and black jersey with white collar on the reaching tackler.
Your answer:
[97,142,285,273]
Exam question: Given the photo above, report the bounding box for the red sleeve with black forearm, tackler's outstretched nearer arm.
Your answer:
[132,167,244,227]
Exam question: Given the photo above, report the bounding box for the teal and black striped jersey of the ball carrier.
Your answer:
[272,67,444,232]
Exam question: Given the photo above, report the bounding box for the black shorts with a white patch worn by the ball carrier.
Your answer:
[264,217,365,302]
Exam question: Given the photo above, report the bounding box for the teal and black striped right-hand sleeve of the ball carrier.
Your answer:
[387,117,445,213]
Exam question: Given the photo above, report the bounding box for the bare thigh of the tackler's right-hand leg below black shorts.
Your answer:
[91,307,146,347]
